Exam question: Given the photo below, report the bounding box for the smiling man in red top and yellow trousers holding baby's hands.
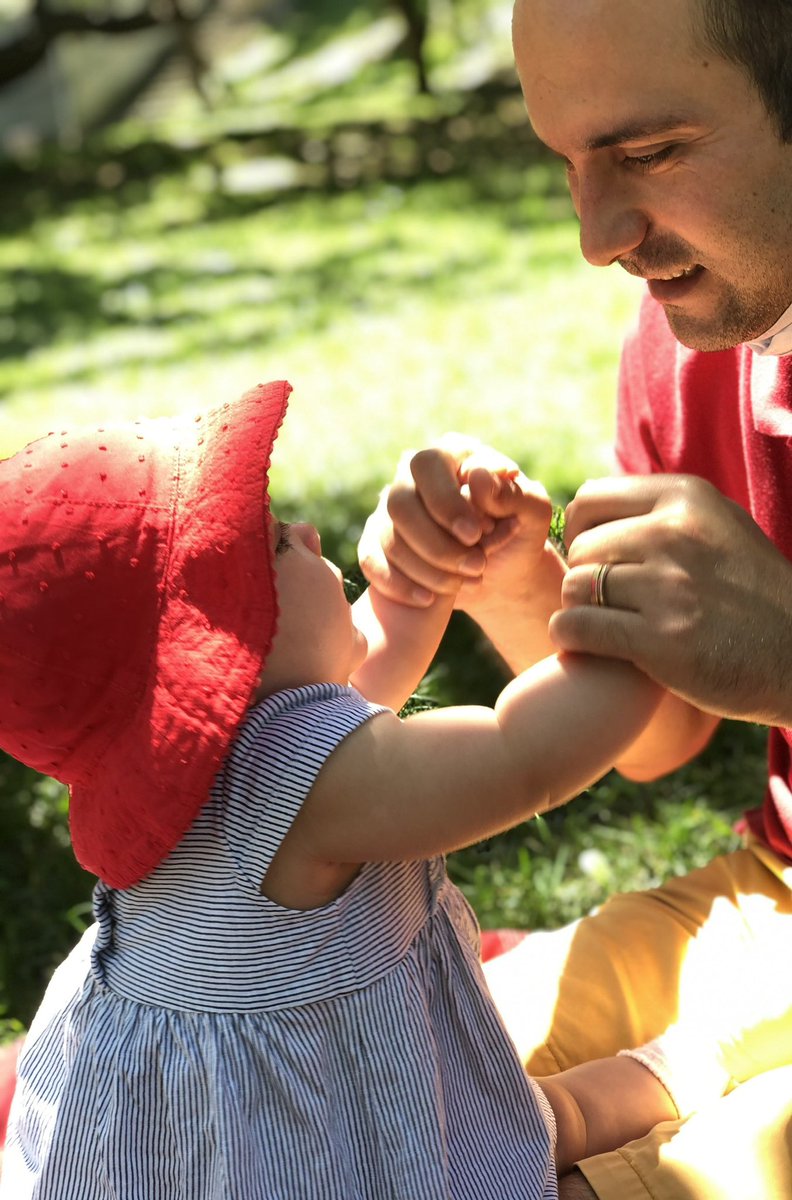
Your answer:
[361,0,792,1200]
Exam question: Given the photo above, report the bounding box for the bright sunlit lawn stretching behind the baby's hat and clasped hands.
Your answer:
[0,167,637,503]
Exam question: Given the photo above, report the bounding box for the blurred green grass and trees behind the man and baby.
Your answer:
[0,0,764,1036]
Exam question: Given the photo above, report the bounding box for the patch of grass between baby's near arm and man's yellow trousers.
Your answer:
[449,721,767,929]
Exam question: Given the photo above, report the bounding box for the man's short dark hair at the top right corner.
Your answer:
[696,0,792,142]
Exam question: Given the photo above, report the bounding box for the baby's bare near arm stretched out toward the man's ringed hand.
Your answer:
[268,655,660,875]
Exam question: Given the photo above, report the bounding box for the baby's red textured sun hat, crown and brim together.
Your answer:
[0,383,290,887]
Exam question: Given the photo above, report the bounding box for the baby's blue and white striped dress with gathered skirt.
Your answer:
[0,684,557,1200]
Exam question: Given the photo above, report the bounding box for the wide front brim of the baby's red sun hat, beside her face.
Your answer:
[71,382,292,888]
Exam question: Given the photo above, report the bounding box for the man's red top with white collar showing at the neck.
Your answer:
[617,296,792,862]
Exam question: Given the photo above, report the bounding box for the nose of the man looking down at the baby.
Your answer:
[572,171,649,266]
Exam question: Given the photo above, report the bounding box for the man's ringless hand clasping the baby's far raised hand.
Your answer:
[359,434,558,616]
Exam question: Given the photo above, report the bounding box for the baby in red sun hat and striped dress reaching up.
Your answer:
[0,383,677,1200]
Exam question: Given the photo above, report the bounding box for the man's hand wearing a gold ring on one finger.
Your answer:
[551,475,792,726]
